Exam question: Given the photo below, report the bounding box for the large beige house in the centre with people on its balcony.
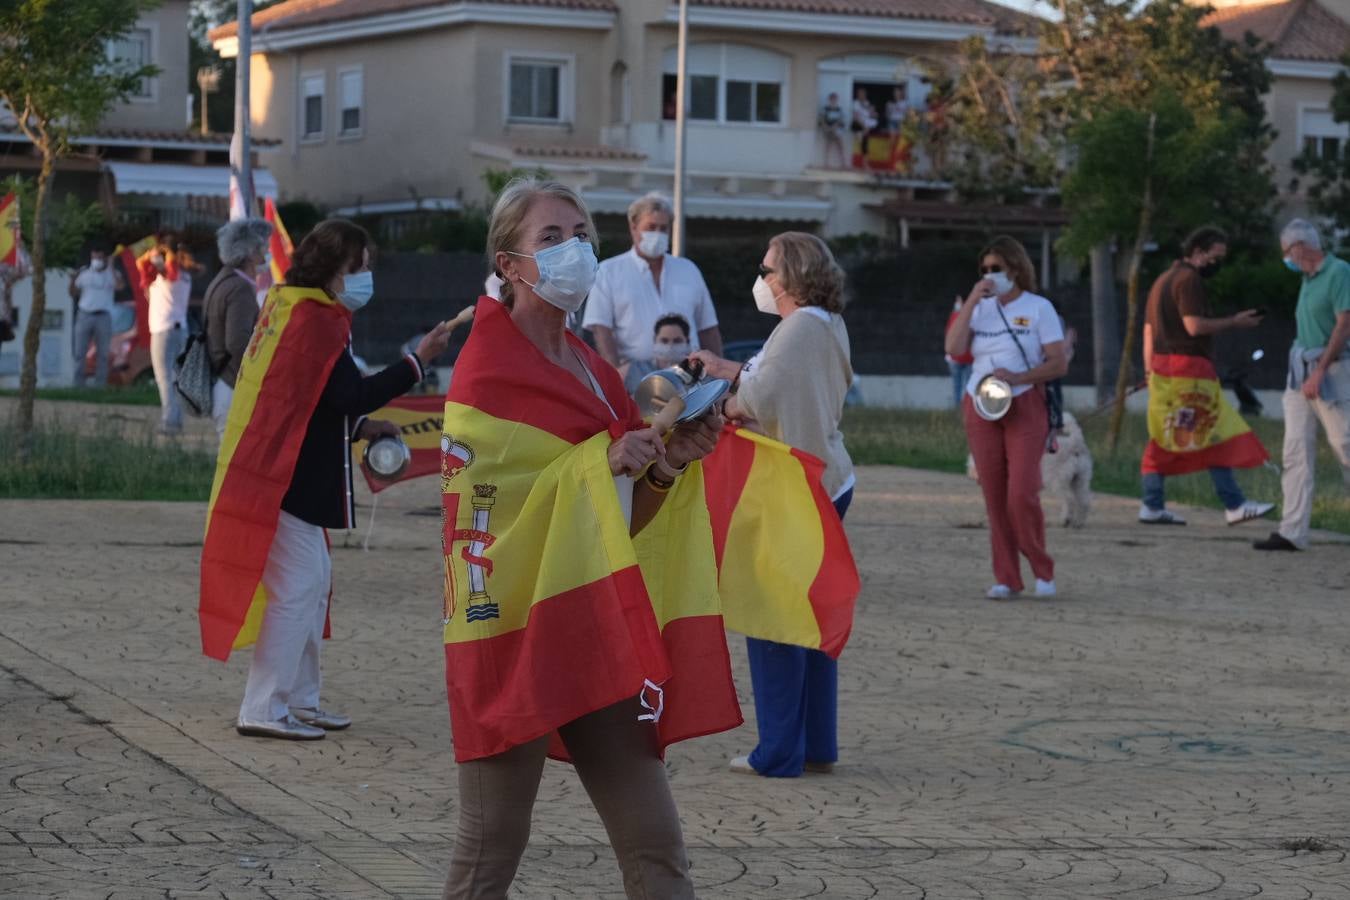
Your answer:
[211,0,1044,239]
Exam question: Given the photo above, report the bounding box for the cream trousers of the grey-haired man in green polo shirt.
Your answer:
[1280,388,1350,549]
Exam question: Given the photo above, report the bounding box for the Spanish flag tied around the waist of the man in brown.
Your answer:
[1139,354,1269,475]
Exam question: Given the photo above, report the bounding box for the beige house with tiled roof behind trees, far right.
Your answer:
[1207,0,1350,219]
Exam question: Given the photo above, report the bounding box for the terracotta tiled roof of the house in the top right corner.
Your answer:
[1204,0,1350,62]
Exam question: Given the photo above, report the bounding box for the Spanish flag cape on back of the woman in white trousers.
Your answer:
[197,285,351,660]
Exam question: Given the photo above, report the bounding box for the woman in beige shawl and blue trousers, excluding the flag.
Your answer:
[694,231,855,777]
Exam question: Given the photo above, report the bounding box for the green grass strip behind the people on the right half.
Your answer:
[841,407,1350,534]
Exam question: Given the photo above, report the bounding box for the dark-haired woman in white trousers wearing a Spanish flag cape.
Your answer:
[198,219,450,741]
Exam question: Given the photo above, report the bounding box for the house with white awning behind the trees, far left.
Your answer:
[0,0,277,231]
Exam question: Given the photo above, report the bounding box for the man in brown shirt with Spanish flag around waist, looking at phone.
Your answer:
[1139,225,1274,525]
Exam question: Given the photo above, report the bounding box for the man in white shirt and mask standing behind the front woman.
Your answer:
[582,193,722,371]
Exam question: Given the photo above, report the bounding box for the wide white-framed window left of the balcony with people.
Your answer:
[662,43,788,125]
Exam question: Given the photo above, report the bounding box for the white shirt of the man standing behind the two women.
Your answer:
[582,248,717,363]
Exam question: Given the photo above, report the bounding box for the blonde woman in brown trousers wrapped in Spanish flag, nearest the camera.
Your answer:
[441,179,741,899]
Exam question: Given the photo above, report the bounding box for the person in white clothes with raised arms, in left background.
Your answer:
[139,242,192,434]
